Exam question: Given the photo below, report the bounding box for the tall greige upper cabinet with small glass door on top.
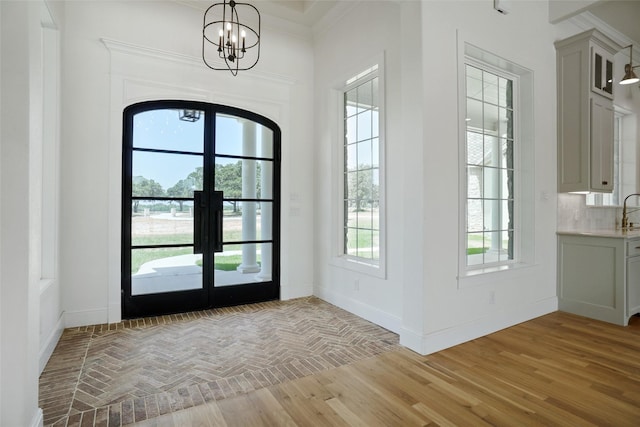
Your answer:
[555,29,620,193]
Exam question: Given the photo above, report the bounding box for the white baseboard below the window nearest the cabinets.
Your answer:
[412,297,558,355]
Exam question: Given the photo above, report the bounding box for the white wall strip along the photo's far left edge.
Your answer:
[0,1,43,426]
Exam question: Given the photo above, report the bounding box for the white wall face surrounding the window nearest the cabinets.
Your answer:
[422,1,557,351]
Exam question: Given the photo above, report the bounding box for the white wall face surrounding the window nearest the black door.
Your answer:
[314,2,408,331]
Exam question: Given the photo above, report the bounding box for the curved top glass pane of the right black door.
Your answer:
[216,114,273,159]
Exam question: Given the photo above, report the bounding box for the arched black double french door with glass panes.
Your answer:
[122,101,280,318]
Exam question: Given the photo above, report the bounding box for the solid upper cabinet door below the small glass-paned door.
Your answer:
[590,95,613,193]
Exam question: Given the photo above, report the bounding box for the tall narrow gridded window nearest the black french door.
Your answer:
[340,65,383,267]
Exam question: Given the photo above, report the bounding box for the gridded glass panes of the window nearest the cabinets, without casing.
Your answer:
[465,61,519,268]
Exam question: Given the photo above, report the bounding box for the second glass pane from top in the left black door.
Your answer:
[131,151,203,197]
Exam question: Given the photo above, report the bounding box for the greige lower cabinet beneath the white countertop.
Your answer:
[558,235,640,326]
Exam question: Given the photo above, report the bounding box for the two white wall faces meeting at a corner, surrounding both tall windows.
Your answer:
[316,0,557,353]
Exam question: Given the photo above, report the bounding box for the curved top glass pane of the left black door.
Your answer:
[133,109,205,153]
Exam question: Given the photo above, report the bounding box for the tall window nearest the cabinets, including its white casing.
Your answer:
[458,43,536,287]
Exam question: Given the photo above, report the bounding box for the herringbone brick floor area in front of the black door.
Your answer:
[40,297,399,427]
